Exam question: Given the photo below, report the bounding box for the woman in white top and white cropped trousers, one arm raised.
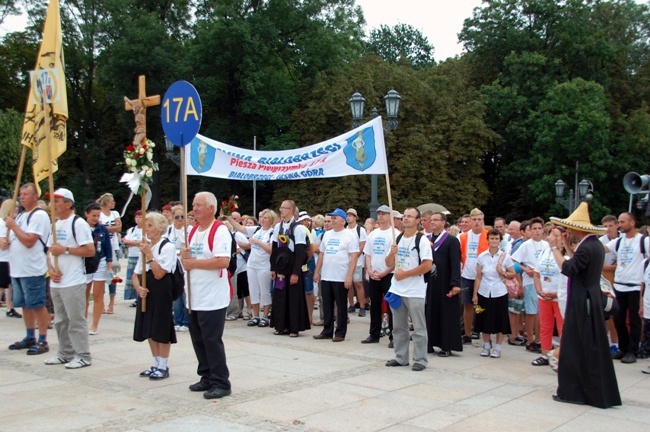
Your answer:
[228,209,277,327]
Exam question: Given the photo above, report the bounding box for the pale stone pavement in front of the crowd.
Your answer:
[0,276,650,432]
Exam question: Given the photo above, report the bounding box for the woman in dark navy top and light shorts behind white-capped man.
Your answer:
[84,202,115,335]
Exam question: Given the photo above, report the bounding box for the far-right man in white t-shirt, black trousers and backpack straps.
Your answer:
[605,212,650,363]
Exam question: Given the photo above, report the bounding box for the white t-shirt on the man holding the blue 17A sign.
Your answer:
[186,222,232,311]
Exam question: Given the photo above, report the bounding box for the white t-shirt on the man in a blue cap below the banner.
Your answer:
[320,229,359,282]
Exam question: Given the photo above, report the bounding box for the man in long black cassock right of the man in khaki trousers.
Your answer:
[425,213,463,357]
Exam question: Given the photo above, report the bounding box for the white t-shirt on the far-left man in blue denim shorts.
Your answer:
[9,209,52,278]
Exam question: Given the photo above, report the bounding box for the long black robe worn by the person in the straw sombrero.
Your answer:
[557,235,621,408]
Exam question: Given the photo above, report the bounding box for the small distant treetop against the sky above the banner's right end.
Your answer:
[368,24,435,68]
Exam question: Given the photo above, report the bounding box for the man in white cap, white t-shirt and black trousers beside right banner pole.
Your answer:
[361,205,399,344]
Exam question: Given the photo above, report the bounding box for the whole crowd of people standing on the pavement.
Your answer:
[0,184,650,408]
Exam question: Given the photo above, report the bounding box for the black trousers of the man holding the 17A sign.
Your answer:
[189,308,230,389]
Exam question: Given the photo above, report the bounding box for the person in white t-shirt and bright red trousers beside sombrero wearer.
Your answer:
[531,226,565,366]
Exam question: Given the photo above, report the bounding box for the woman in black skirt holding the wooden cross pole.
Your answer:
[132,212,176,380]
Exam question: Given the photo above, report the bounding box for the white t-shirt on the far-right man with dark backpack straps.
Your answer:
[607,233,650,292]
